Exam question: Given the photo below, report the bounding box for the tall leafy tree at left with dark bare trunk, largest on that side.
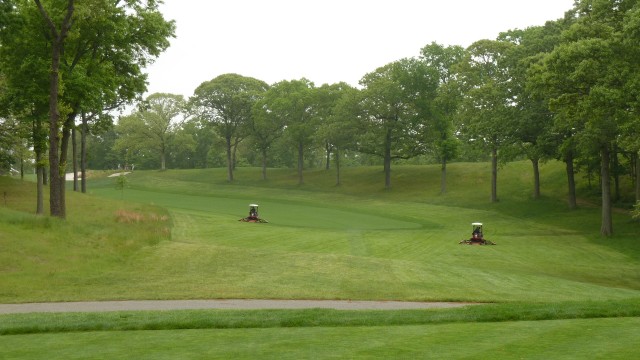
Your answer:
[2,0,174,217]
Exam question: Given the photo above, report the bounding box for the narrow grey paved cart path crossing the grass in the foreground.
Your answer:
[0,299,473,314]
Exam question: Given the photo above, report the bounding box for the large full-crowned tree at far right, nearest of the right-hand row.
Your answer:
[545,0,638,236]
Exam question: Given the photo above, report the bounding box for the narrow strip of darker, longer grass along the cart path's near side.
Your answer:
[0,299,640,335]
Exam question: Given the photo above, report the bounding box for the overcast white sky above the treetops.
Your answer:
[147,0,573,97]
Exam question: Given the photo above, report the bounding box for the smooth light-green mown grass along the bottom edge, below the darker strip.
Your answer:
[0,317,640,360]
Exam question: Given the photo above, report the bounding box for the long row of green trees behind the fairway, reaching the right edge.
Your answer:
[0,0,640,236]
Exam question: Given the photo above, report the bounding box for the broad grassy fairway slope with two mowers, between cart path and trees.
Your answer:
[0,163,640,302]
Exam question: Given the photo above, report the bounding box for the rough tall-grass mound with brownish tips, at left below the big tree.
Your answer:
[0,178,171,302]
